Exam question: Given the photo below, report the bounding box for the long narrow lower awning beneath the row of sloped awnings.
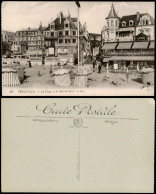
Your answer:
[109,56,154,61]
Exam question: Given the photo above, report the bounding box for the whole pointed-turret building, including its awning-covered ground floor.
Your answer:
[102,5,155,68]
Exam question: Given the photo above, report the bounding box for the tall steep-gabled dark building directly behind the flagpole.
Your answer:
[45,12,88,55]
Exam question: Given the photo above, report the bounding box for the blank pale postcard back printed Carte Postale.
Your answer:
[2,98,155,193]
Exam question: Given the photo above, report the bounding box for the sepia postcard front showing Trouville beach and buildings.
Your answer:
[1,1,155,96]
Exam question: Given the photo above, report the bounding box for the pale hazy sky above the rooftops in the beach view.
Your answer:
[2,1,155,33]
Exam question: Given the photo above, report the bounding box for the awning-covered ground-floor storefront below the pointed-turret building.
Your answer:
[103,38,154,69]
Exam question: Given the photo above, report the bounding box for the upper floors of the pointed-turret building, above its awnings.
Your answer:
[101,4,154,43]
